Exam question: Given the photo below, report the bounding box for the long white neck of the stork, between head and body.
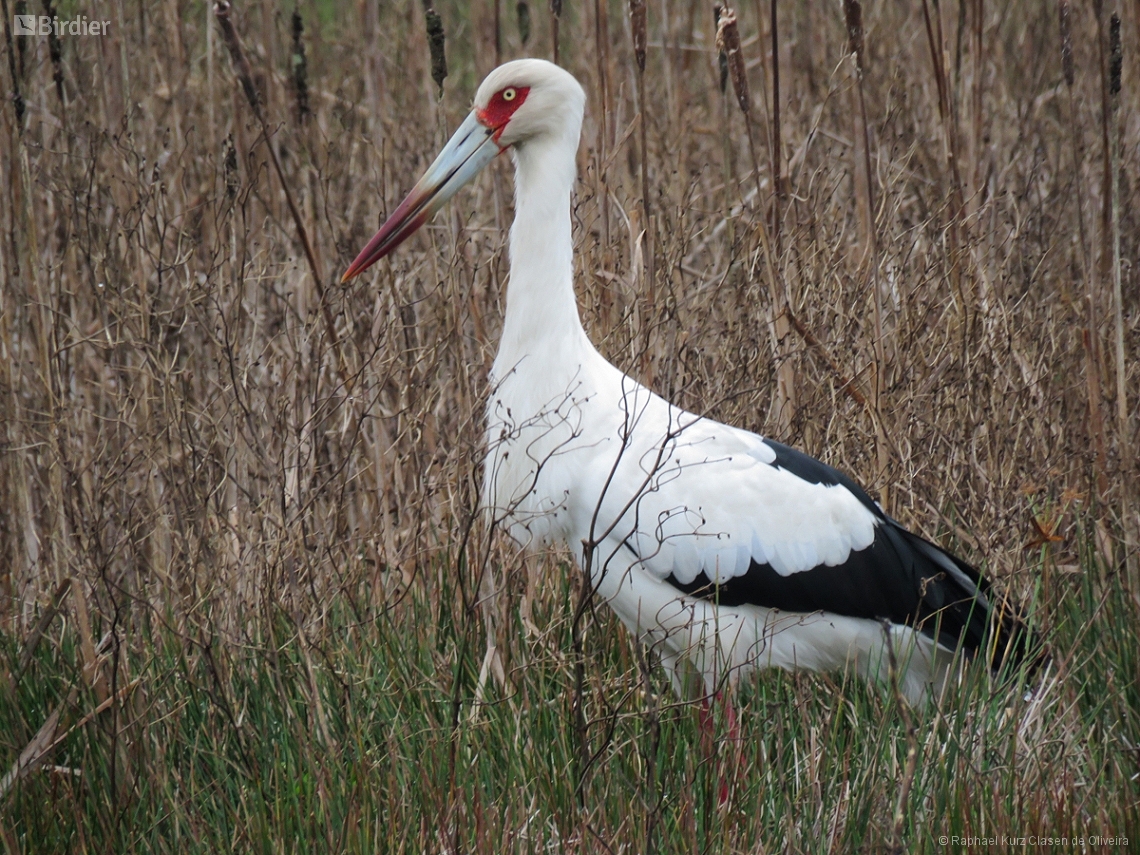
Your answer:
[495,127,592,378]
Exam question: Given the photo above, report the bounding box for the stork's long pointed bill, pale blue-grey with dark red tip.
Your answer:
[341,113,503,282]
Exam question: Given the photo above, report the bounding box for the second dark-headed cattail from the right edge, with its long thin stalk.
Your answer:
[1059,0,1108,502]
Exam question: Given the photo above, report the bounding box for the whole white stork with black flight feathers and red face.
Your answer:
[343,59,1028,702]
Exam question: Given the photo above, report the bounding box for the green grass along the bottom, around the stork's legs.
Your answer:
[0,551,1140,853]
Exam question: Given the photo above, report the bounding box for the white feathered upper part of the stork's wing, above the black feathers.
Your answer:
[605,407,880,585]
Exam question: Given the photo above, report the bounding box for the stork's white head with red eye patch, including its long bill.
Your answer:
[341,59,586,282]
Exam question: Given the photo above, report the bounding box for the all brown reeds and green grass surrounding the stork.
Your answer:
[0,0,1140,852]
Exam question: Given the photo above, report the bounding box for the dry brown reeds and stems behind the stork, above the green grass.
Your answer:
[0,0,1140,848]
